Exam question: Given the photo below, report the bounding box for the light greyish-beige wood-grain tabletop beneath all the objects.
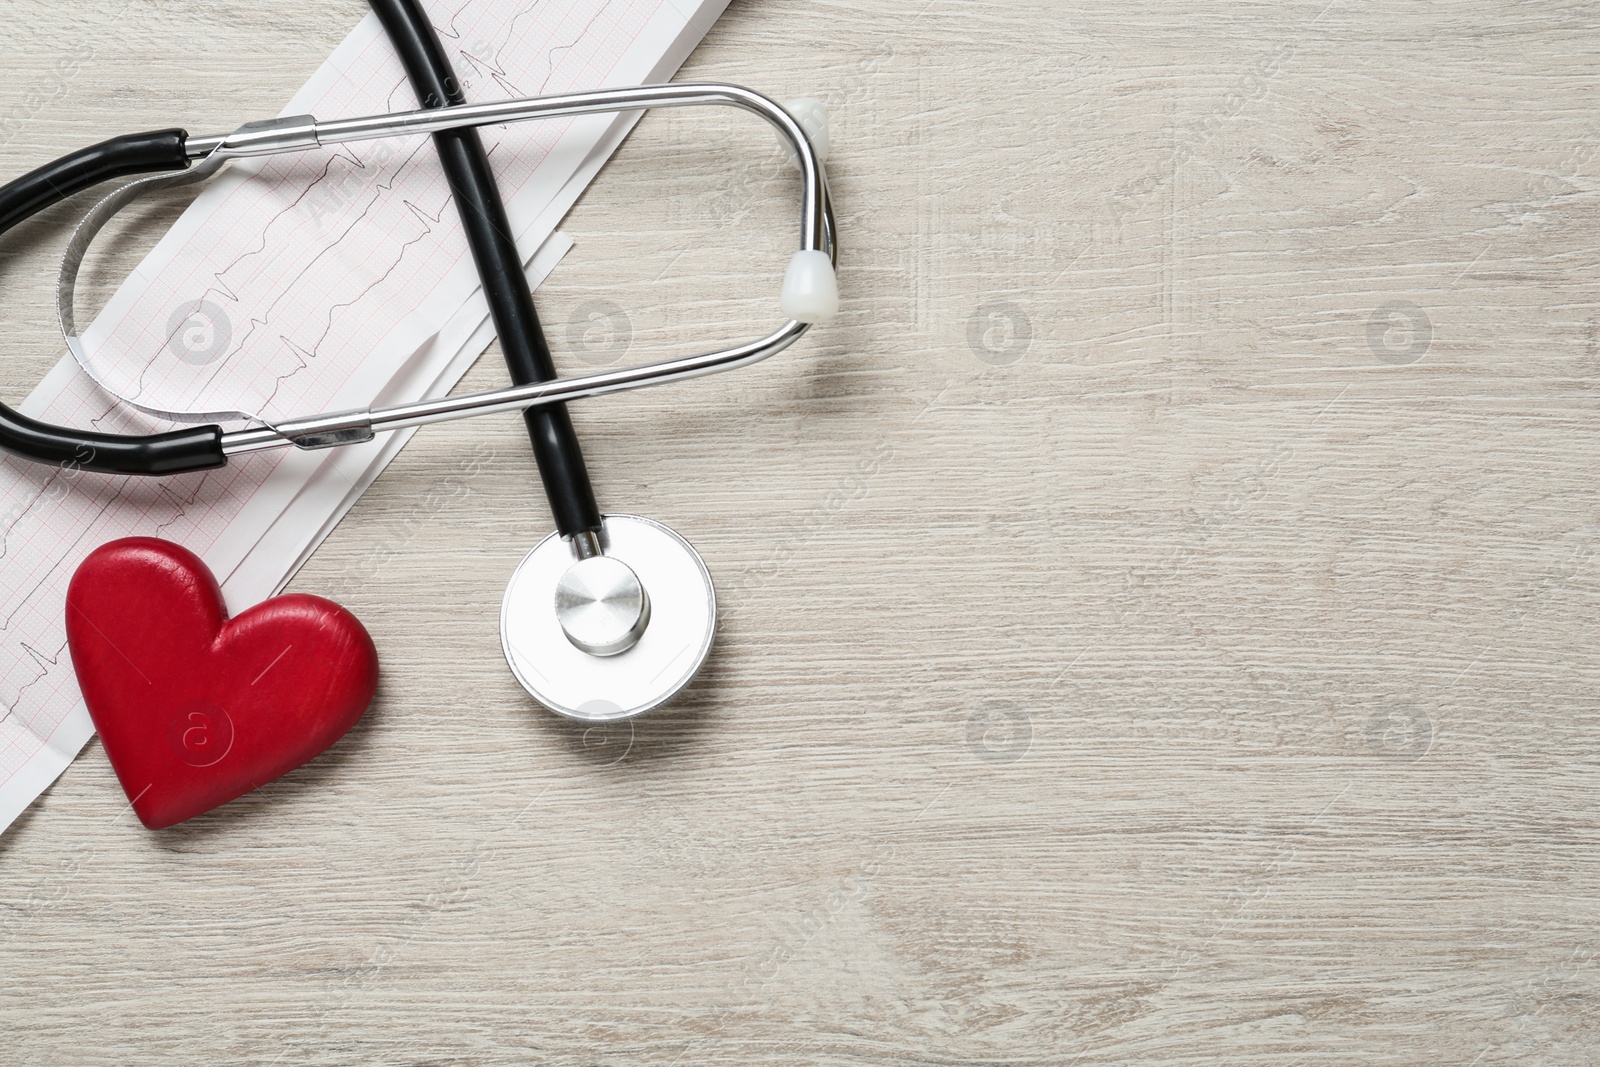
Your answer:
[0,0,1600,1065]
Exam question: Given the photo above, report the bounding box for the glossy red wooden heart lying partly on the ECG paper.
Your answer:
[67,537,378,830]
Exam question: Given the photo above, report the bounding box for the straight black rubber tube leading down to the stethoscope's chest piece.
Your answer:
[370,0,600,537]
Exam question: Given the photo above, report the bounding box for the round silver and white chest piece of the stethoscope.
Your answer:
[501,515,717,721]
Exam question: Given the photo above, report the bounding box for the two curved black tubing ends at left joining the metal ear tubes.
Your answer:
[0,130,227,475]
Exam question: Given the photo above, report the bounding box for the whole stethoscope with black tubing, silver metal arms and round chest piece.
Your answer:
[0,0,838,721]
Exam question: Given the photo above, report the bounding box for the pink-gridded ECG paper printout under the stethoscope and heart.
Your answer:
[0,0,728,829]
